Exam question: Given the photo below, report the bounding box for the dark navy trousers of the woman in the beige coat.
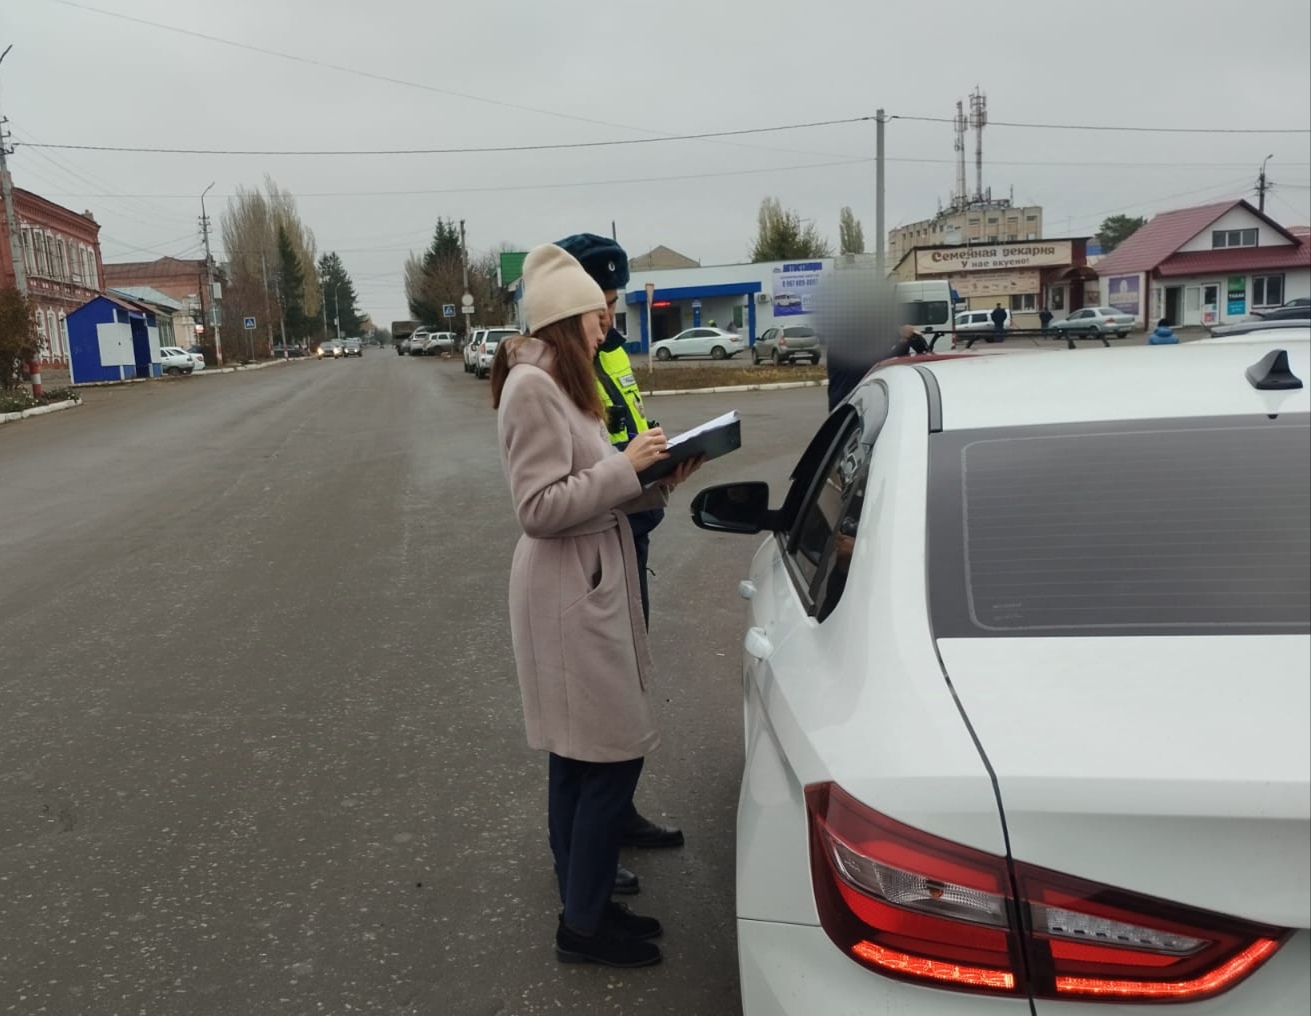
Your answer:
[547,752,644,935]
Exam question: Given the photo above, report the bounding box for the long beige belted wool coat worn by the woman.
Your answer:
[497,337,667,762]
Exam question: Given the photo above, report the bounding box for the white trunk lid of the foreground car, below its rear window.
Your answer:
[939,636,1311,928]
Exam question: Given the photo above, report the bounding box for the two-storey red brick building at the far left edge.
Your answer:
[0,187,105,363]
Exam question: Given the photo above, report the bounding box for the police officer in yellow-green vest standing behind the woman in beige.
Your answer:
[557,233,683,875]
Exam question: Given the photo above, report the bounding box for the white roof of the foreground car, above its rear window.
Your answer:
[912,333,1311,430]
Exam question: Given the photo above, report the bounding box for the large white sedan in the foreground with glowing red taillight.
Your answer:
[692,337,1311,1016]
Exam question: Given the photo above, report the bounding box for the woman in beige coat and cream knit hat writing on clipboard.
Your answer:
[492,244,695,966]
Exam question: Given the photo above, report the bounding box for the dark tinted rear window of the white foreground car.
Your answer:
[928,414,1311,637]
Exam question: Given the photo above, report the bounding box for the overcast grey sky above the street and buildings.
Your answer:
[0,0,1311,325]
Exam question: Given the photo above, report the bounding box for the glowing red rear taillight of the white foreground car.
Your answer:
[806,783,1290,1002]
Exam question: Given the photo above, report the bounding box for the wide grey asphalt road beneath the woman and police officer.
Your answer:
[0,350,825,1016]
